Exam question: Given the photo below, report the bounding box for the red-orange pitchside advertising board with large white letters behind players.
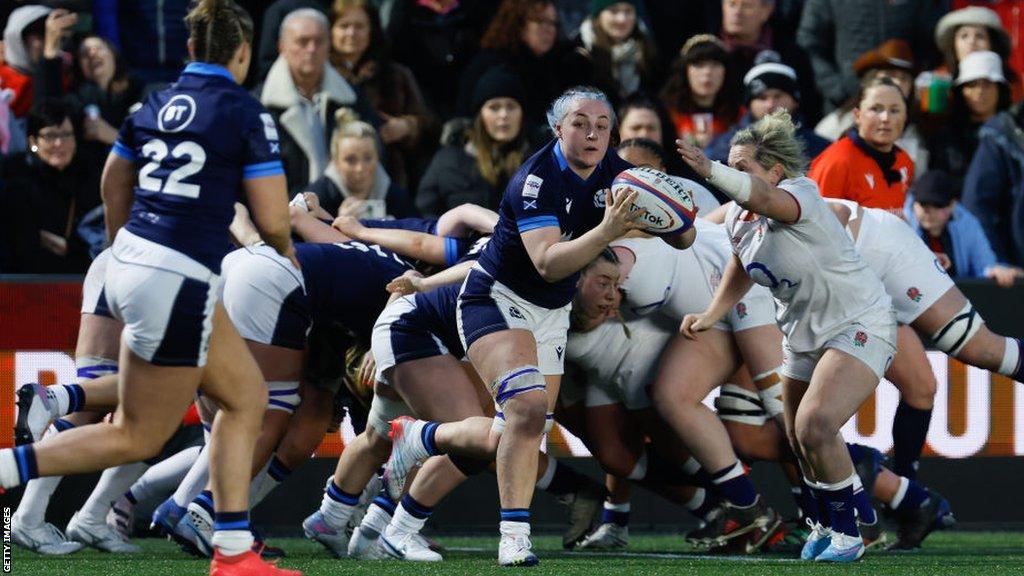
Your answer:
[0,279,1024,458]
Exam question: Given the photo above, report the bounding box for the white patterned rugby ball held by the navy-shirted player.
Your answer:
[611,167,697,236]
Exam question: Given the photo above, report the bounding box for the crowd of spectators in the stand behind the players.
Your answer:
[0,0,1024,284]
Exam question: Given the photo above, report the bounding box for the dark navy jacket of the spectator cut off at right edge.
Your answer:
[962,94,1024,266]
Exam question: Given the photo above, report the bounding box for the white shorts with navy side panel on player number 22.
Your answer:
[104,229,221,366]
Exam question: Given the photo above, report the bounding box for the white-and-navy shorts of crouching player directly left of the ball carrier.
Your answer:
[370,296,452,383]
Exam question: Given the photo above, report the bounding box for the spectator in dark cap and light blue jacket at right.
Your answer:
[903,170,1024,288]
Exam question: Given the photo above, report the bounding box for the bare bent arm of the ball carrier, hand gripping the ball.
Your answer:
[518,191,644,282]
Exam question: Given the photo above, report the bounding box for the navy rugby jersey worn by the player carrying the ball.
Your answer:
[480,139,633,308]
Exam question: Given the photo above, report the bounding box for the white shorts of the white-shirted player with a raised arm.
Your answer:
[782,323,896,382]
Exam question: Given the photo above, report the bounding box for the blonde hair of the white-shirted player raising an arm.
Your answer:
[729,110,807,178]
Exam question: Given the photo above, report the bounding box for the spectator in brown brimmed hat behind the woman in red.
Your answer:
[814,40,928,169]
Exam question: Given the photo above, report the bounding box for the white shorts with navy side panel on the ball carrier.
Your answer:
[457,266,572,375]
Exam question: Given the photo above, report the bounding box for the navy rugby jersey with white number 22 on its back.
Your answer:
[113,63,286,274]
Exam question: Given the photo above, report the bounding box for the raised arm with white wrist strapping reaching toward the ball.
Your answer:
[676,140,800,223]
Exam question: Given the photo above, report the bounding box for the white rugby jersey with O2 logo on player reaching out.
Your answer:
[724,176,895,353]
